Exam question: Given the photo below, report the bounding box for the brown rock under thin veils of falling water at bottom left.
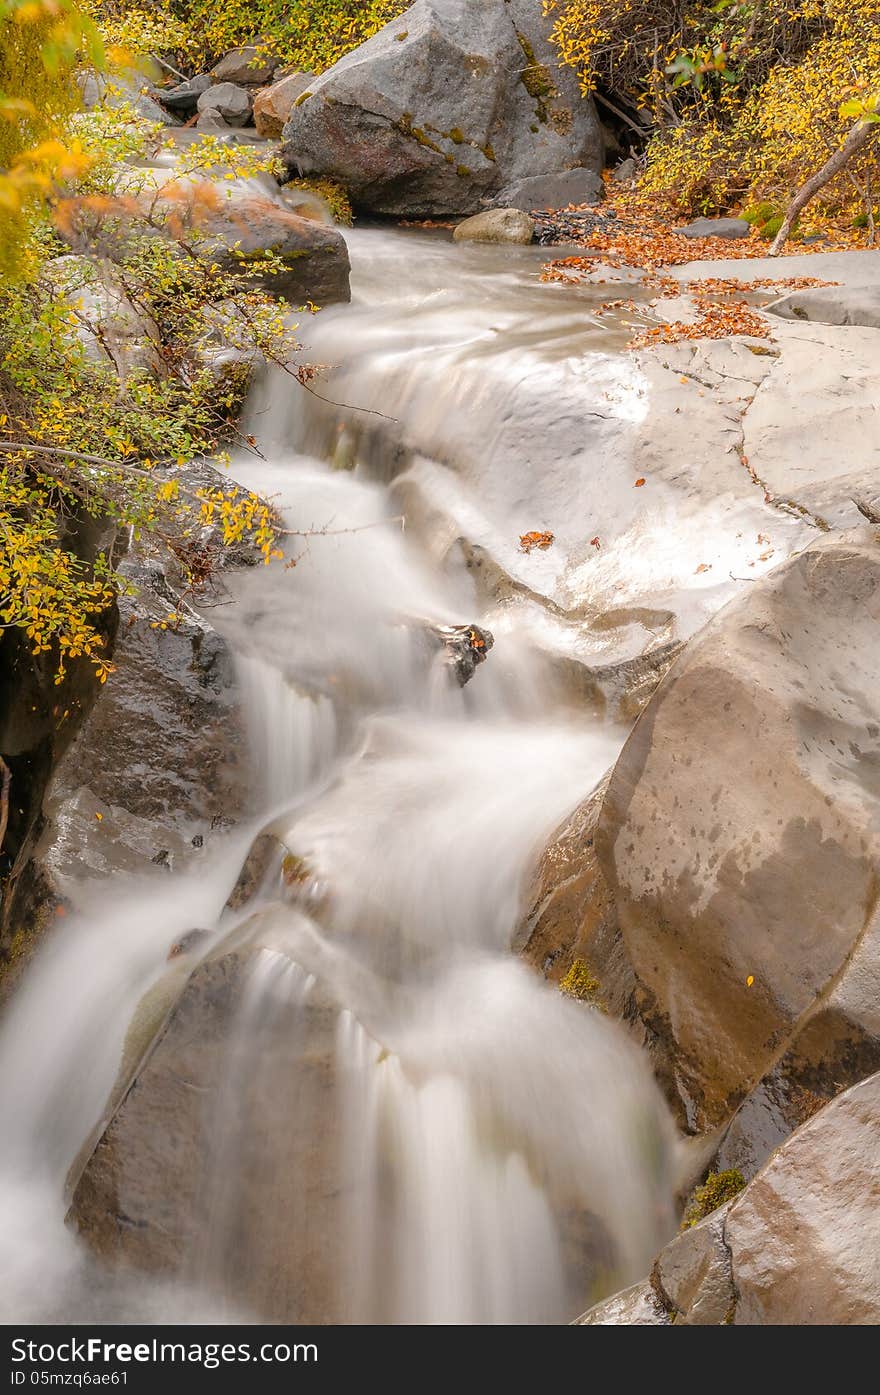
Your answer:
[70,947,350,1322]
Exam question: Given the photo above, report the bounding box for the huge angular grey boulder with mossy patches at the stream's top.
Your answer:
[285,0,602,216]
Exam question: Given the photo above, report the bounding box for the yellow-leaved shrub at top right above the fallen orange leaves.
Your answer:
[552,0,880,216]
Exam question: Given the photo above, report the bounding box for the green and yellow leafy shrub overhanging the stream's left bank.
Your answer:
[0,0,302,684]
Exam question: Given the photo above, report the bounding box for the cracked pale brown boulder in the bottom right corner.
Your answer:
[579,1076,880,1327]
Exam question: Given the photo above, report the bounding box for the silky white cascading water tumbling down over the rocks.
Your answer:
[0,223,675,1322]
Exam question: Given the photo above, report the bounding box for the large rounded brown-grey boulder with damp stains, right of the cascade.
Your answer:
[597,527,880,1149]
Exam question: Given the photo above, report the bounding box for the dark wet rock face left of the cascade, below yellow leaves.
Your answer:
[36,466,250,894]
